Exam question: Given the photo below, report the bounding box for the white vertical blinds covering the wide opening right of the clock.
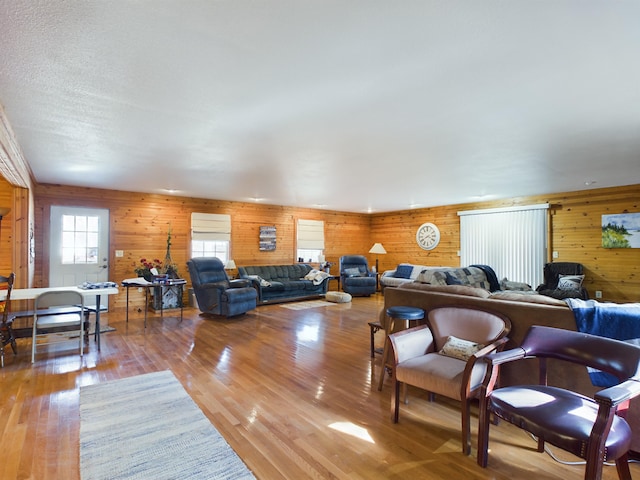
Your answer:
[458,204,549,288]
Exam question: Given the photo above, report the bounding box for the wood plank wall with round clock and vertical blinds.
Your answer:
[371,185,640,302]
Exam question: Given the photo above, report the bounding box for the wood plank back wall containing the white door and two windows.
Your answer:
[34,185,372,308]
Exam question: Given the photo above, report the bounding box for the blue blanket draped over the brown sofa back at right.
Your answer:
[565,298,640,387]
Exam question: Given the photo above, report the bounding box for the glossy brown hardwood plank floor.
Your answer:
[0,294,640,480]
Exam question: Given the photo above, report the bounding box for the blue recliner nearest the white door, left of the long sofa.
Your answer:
[187,257,258,317]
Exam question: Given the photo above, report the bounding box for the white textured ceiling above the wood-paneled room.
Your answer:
[0,0,640,212]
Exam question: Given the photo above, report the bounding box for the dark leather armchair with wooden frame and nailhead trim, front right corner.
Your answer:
[477,326,640,480]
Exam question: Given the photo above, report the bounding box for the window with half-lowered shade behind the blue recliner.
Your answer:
[191,212,231,264]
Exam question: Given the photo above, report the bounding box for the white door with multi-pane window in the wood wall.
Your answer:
[49,206,109,305]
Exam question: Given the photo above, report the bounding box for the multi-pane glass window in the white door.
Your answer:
[62,215,100,265]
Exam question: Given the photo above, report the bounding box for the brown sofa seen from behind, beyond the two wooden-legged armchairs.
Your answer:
[380,283,640,452]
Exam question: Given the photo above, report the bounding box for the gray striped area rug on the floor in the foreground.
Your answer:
[80,370,255,480]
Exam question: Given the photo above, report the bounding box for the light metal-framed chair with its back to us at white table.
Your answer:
[31,290,87,363]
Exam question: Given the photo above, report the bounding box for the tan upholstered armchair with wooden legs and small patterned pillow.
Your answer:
[389,306,511,455]
